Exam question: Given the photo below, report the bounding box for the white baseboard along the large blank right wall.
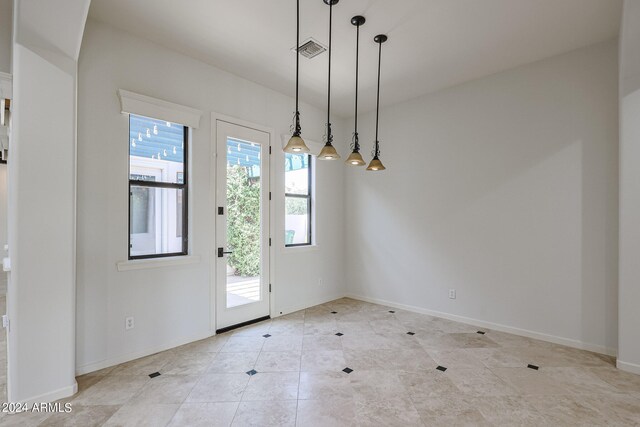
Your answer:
[346,294,617,356]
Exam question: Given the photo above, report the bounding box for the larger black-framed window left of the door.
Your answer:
[129,114,189,259]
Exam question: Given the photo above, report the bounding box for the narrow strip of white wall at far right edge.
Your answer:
[618,0,640,374]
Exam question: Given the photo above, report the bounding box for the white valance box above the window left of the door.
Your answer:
[118,89,202,129]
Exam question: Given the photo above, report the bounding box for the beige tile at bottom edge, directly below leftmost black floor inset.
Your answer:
[104,404,180,427]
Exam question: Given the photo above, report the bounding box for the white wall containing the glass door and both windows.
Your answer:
[76,20,345,372]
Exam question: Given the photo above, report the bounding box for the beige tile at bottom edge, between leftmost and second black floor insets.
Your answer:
[169,402,239,427]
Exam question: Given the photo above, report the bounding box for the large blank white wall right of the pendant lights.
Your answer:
[345,41,620,353]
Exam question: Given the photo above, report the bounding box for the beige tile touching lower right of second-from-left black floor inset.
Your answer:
[242,371,300,401]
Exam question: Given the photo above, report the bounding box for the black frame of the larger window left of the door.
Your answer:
[127,114,189,260]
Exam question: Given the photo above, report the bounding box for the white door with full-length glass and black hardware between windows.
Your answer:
[214,120,270,330]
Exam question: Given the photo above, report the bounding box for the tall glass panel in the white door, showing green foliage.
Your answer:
[226,138,262,308]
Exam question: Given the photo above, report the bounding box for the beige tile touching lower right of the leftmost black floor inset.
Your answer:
[129,375,199,404]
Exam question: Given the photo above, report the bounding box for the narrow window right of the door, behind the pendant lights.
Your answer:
[284,153,312,247]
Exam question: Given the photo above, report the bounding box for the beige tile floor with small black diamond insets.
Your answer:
[0,299,640,427]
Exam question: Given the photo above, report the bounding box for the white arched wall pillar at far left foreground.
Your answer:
[7,0,89,402]
